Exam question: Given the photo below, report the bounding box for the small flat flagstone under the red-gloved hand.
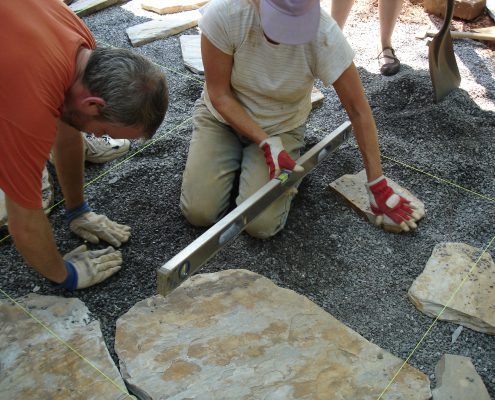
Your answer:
[330,169,425,232]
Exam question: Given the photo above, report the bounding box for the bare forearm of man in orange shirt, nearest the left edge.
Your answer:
[5,196,67,283]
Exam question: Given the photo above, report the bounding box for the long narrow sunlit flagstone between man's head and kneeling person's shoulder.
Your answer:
[126,10,201,47]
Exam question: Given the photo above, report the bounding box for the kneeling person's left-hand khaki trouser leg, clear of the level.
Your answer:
[180,101,242,226]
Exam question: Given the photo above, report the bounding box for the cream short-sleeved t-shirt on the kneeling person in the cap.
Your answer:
[199,0,354,135]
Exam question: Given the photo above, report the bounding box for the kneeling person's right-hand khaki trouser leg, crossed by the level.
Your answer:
[236,127,304,239]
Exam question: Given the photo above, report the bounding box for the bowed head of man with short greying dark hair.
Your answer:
[61,48,168,138]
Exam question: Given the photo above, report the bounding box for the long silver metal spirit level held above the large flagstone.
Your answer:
[158,122,351,296]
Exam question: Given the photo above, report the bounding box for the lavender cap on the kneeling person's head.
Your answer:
[260,0,322,44]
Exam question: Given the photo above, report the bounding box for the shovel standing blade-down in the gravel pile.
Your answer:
[428,0,461,103]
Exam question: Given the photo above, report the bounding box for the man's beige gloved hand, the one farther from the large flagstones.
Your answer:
[66,202,131,247]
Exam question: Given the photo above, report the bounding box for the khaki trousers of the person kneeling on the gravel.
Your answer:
[180,99,304,238]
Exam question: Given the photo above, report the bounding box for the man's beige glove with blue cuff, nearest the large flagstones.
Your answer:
[55,245,122,290]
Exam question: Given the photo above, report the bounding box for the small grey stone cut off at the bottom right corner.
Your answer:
[432,354,490,400]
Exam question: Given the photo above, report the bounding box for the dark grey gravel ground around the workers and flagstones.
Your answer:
[0,0,495,396]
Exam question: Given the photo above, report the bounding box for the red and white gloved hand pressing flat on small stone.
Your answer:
[367,175,424,232]
